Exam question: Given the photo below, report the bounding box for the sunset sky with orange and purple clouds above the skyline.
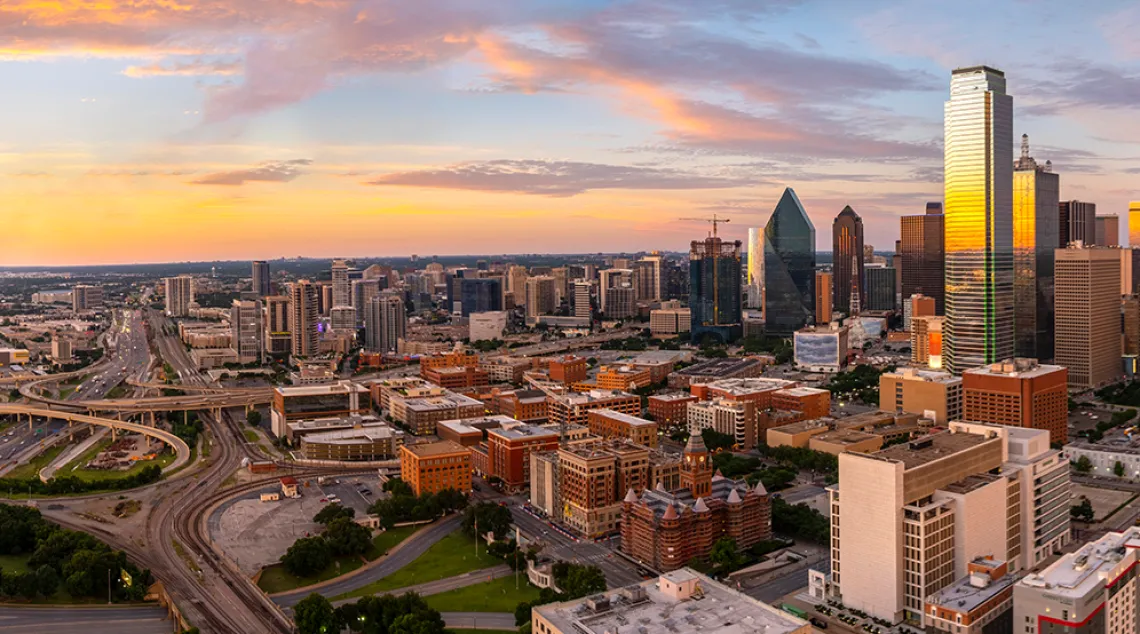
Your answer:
[0,0,1140,266]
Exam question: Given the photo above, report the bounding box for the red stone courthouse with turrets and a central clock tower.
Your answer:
[621,436,772,572]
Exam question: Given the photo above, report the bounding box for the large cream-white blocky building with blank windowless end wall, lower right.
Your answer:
[828,422,1072,620]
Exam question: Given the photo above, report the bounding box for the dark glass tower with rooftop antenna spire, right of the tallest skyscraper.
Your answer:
[1013,135,1060,359]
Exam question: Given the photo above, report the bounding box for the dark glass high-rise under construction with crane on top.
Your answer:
[689,223,743,343]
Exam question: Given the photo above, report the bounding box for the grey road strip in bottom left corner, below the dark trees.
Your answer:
[0,605,174,634]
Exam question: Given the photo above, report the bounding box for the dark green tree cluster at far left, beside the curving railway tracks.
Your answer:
[0,504,150,601]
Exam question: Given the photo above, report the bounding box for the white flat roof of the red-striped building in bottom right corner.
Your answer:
[1019,527,1140,599]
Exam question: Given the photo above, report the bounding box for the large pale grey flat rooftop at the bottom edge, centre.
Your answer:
[535,568,811,634]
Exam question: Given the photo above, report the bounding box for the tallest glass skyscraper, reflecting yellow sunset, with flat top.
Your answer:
[944,66,1013,374]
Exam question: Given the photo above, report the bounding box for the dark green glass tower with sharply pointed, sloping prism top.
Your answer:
[761,187,815,336]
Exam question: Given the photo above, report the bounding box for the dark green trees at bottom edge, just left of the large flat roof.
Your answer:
[293,592,446,634]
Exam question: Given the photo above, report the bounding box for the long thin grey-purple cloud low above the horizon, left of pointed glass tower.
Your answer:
[367,160,759,197]
